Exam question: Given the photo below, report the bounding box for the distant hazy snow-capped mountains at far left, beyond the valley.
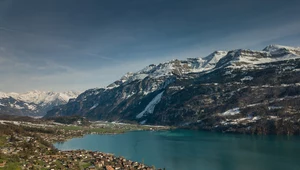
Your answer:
[0,90,79,116]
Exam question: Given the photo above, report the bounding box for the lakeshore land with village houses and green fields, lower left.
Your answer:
[0,120,166,170]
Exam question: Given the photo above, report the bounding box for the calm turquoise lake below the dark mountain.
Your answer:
[55,130,300,170]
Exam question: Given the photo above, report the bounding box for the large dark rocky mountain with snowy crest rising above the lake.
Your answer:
[46,45,300,134]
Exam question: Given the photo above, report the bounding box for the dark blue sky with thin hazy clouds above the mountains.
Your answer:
[0,0,300,92]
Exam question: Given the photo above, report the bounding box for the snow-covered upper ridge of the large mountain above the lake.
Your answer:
[108,45,300,88]
